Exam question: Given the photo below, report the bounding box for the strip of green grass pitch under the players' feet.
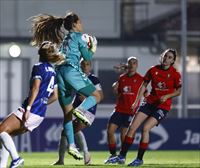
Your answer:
[9,151,200,168]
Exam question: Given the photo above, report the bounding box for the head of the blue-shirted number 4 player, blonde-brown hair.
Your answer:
[38,41,61,63]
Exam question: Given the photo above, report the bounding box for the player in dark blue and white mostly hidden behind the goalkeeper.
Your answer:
[53,59,103,165]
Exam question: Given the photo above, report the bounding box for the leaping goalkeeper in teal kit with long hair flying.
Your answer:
[29,12,101,159]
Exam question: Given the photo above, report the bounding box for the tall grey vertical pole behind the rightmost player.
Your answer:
[180,0,188,118]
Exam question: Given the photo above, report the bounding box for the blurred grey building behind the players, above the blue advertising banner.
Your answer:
[0,0,200,118]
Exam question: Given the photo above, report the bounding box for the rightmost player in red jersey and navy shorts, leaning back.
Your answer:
[108,49,181,166]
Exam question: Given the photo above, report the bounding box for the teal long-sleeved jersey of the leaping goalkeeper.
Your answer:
[60,32,93,69]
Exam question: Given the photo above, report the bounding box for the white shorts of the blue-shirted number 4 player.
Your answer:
[12,107,44,131]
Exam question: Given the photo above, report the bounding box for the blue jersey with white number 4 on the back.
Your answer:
[22,62,56,117]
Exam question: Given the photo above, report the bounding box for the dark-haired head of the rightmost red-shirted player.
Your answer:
[160,48,177,66]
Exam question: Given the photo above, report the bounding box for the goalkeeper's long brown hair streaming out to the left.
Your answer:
[29,12,79,46]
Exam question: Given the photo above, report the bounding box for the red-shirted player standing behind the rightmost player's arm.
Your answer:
[105,57,147,164]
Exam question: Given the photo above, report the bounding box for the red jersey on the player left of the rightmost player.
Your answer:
[115,73,143,115]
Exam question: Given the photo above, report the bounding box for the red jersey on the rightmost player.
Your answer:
[144,65,181,111]
